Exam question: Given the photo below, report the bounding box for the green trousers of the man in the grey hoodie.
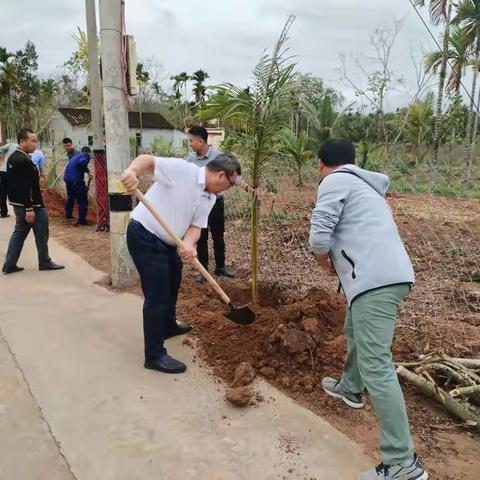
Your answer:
[341,285,414,465]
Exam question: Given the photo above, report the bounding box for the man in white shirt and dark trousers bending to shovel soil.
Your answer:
[121,154,241,373]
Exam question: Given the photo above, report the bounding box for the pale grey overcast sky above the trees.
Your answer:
[0,0,432,108]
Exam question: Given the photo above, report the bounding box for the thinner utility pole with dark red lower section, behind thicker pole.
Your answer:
[85,0,109,232]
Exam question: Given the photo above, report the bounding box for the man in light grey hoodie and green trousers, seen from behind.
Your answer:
[310,140,428,480]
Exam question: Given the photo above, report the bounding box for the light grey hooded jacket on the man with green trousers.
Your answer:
[310,165,415,305]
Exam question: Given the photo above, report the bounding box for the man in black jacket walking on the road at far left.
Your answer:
[2,128,64,275]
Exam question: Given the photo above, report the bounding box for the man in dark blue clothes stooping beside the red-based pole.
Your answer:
[63,147,90,225]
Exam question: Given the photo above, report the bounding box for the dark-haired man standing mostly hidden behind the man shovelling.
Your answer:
[187,125,235,283]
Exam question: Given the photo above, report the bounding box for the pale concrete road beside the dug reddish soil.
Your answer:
[0,218,370,480]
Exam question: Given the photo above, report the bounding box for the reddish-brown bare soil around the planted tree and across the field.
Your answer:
[42,181,480,480]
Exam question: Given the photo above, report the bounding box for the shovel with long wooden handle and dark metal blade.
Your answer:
[135,188,256,325]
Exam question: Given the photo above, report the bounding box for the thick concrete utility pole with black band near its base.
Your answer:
[100,0,137,287]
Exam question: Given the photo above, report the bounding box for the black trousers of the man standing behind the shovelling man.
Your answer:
[197,197,225,270]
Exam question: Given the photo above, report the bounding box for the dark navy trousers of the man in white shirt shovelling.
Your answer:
[127,220,183,361]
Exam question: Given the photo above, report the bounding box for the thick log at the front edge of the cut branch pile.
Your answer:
[397,366,480,431]
